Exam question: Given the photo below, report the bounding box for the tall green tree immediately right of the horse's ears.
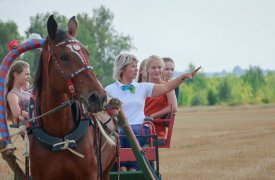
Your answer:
[81,6,133,85]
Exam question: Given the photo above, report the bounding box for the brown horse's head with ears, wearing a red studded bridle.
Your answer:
[35,15,107,112]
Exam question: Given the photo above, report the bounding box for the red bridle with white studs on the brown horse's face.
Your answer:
[48,39,94,97]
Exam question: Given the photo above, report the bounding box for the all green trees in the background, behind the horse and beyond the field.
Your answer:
[0,6,275,106]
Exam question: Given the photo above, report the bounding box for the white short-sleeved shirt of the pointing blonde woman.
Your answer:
[105,81,154,125]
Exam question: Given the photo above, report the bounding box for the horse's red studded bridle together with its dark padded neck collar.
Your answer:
[28,40,95,152]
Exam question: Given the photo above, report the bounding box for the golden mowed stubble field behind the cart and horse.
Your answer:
[0,104,275,180]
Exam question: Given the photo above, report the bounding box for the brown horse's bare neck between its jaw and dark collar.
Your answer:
[40,87,75,137]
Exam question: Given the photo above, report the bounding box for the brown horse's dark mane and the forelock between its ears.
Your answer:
[33,29,67,98]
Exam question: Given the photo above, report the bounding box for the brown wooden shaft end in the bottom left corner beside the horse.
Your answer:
[1,151,25,180]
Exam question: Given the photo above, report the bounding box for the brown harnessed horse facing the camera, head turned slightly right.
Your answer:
[30,16,114,180]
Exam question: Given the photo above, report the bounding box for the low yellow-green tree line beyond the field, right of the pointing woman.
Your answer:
[179,65,275,106]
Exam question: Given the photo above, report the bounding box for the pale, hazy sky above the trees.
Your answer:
[0,0,275,72]
